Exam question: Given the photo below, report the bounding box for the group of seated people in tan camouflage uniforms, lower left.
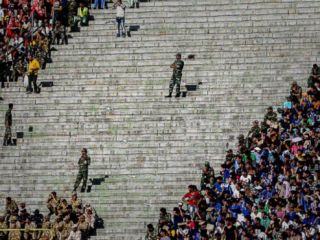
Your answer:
[0,192,100,240]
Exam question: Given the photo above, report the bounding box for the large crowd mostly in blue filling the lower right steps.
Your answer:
[145,68,320,240]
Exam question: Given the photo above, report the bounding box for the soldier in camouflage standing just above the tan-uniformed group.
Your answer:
[73,148,91,192]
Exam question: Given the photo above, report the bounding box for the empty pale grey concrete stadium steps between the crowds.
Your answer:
[0,0,320,240]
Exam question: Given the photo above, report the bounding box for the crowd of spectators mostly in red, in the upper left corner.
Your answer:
[0,0,90,92]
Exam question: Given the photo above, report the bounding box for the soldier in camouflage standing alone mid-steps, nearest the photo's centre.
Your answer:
[166,53,184,97]
